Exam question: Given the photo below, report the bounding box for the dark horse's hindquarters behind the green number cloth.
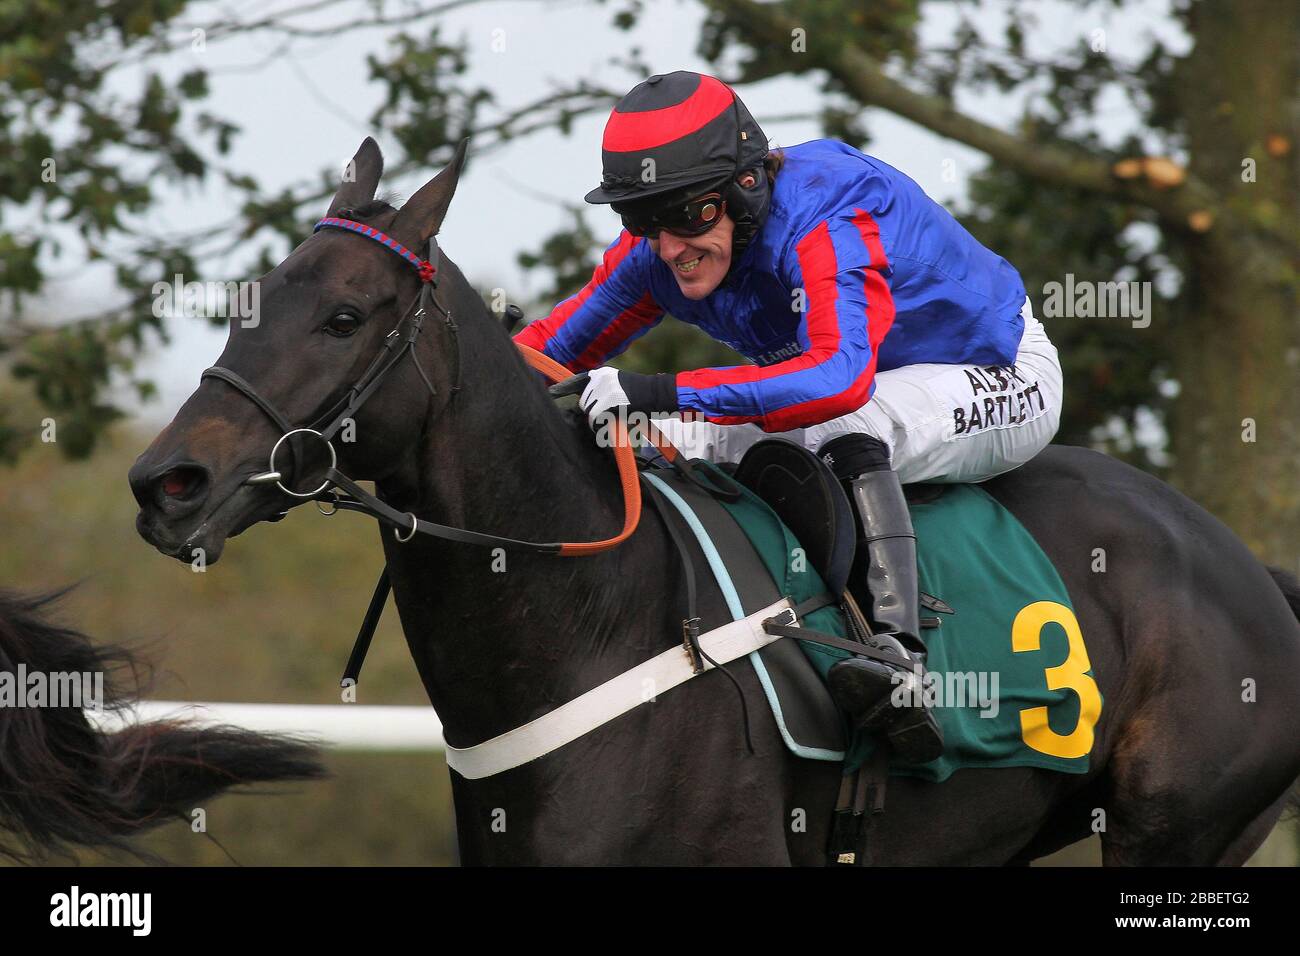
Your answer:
[985,447,1300,865]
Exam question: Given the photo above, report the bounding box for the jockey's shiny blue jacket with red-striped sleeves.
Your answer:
[516,140,1024,432]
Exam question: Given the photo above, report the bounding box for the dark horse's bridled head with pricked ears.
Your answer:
[129,138,473,563]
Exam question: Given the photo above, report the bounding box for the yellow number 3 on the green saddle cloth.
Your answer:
[1011,601,1101,757]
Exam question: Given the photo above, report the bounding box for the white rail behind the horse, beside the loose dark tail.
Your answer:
[86,700,445,753]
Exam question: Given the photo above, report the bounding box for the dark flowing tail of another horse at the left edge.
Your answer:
[0,589,324,861]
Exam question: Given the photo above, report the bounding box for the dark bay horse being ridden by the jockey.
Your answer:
[130,139,1300,865]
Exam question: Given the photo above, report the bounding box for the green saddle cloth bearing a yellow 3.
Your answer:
[707,465,1102,782]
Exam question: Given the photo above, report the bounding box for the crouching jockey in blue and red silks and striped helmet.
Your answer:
[516,72,1062,762]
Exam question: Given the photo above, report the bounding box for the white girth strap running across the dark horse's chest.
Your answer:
[447,598,797,780]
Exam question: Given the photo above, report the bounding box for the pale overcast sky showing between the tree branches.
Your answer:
[30,0,1190,420]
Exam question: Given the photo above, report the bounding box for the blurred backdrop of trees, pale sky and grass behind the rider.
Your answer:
[0,0,1300,865]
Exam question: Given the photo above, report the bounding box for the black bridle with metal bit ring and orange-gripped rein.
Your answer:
[200,217,641,557]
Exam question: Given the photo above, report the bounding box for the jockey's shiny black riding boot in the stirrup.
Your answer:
[819,434,944,763]
